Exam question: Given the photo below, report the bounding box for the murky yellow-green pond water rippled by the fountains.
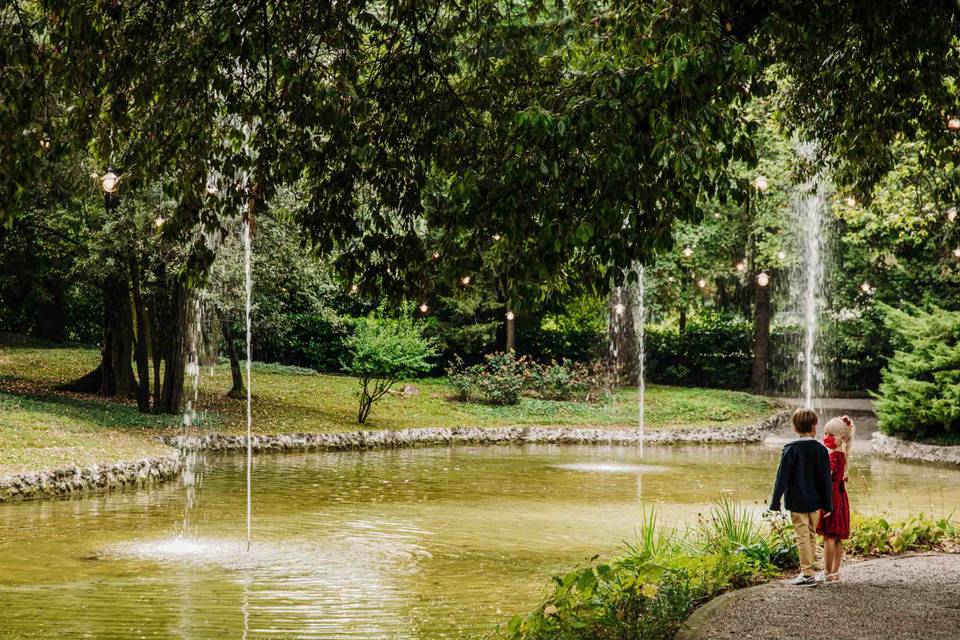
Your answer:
[0,445,960,639]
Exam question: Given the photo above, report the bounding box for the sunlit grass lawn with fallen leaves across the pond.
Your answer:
[0,335,776,475]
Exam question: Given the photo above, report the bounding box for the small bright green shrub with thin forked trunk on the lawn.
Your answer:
[342,317,436,424]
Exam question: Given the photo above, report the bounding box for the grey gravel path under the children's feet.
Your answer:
[679,554,960,640]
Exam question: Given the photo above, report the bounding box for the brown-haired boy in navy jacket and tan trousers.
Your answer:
[770,409,833,587]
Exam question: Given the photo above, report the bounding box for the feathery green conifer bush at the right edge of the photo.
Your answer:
[876,305,960,438]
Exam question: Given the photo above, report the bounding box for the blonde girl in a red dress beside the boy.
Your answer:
[817,416,856,582]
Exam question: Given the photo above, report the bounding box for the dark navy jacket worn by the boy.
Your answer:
[770,438,833,513]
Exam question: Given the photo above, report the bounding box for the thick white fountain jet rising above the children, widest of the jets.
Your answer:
[790,142,829,416]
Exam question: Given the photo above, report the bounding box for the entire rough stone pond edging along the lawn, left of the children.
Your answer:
[0,411,790,503]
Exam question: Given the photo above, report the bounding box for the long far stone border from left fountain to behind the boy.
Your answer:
[163,411,791,453]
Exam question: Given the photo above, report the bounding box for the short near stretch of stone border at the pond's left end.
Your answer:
[0,452,183,503]
